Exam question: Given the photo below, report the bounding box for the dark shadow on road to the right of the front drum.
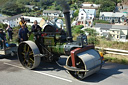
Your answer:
[83,63,128,82]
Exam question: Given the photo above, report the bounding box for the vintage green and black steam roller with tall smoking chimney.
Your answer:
[18,0,103,80]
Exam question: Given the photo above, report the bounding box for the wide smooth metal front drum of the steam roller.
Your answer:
[66,49,102,80]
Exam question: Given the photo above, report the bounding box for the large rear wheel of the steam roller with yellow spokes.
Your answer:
[18,41,40,69]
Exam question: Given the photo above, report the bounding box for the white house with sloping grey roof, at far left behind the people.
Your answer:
[1,14,22,27]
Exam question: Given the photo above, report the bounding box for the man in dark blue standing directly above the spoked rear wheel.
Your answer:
[18,24,29,42]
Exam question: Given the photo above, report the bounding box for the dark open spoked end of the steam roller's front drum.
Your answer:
[66,57,86,80]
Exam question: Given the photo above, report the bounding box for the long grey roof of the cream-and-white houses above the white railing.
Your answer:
[95,23,128,30]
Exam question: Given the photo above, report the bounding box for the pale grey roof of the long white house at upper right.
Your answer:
[100,12,127,17]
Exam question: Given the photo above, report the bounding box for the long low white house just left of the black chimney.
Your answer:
[43,10,61,17]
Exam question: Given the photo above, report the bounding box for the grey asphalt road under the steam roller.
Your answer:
[0,55,128,85]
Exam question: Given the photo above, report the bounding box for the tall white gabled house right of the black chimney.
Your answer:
[77,8,96,26]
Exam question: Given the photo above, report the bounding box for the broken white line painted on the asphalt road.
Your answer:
[4,63,72,82]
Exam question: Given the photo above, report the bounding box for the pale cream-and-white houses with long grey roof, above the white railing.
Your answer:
[94,23,128,42]
